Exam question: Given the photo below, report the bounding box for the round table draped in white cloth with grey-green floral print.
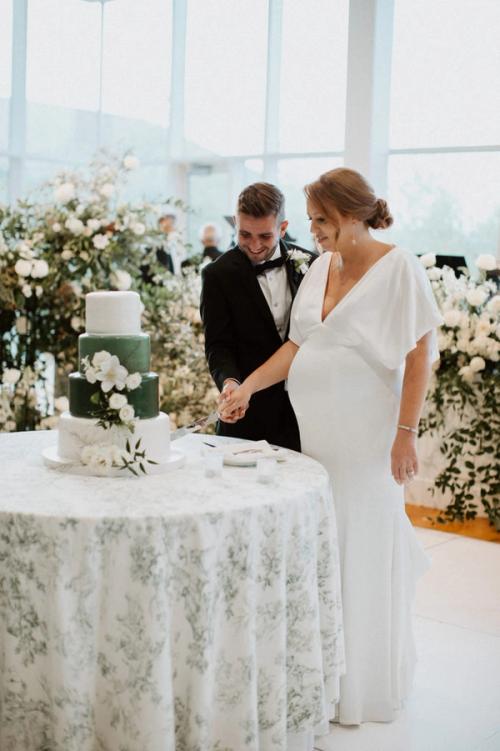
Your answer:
[0,432,344,751]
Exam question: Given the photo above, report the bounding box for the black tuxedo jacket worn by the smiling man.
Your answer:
[200,241,316,451]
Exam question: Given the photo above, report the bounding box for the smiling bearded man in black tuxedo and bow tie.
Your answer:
[201,183,316,451]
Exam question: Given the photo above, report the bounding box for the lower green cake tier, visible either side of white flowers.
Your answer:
[69,373,159,420]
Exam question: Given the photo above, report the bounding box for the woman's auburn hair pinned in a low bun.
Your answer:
[304,167,394,229]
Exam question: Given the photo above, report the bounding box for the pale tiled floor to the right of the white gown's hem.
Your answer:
[316,529,500,751]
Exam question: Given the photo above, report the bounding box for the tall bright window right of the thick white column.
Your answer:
[388,0,500,255]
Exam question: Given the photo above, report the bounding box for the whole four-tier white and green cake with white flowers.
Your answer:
[44,292,179,475]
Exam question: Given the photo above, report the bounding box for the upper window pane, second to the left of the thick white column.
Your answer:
[185,0,267,158]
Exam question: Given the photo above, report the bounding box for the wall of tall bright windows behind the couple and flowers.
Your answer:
[0,0,500,255]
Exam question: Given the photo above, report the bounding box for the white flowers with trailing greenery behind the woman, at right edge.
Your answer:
[420,254,500,530]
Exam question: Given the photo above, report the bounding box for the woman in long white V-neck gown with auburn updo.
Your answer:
[220,168,441,725]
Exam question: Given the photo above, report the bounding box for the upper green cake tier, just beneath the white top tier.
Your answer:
[78,334,151,373]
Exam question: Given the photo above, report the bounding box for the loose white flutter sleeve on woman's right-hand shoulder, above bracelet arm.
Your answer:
[374,251,442,370]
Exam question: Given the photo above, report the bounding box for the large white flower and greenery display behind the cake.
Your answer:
[0,154,217,431]
